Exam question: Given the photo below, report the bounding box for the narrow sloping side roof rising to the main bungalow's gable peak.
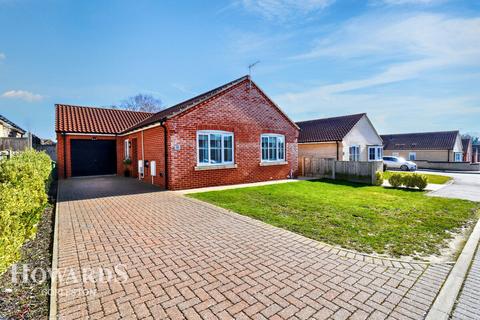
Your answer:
[124,76,249,132]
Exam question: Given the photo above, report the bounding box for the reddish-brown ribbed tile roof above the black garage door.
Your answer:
[55,104,152,134]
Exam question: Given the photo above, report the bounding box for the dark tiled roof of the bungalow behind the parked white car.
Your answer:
[381,131,459,150]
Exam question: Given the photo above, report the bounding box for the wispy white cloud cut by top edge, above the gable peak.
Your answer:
[241,0,334,20]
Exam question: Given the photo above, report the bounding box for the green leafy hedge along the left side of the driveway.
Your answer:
[0,150,52,274]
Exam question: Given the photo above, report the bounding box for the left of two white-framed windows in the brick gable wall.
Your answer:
[197,130,234,166]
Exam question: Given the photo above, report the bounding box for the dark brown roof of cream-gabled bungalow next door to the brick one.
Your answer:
[297,113,366,143]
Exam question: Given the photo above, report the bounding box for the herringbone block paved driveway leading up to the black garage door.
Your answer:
[57,177,451,319]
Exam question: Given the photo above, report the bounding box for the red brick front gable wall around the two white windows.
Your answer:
[166,81,298,189]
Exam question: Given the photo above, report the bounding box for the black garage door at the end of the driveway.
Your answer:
[70,139,117,177]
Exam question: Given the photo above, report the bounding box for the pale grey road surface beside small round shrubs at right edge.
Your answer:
[418,171,480,201]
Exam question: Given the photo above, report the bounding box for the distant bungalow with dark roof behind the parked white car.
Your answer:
[381,131,463,162]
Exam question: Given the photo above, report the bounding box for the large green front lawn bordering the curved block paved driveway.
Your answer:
[189,180,480,256]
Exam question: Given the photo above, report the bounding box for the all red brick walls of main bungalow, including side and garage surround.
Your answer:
[57,81,299,190]
